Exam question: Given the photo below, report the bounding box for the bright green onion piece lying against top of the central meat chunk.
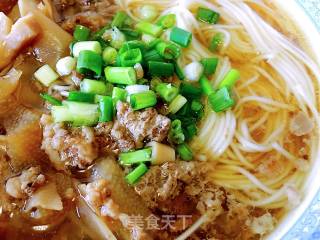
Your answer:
[130,90,157,110]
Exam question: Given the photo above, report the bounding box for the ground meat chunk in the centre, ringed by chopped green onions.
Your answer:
[117,101,170,148]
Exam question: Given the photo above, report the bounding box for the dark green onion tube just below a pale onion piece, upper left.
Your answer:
[77,50,102,76]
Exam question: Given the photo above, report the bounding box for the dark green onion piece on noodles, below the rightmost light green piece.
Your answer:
[209,87,235,112]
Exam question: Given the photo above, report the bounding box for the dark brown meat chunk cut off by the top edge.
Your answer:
[53,0,118,33]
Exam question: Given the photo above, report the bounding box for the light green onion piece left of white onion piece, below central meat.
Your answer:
[119,148,152,165]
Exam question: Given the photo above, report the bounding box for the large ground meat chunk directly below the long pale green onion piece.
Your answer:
[40,115,98,170]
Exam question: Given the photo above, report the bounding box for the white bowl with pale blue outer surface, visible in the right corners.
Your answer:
[267,0,320,240]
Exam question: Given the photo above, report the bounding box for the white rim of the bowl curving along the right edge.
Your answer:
[267,0,320,240]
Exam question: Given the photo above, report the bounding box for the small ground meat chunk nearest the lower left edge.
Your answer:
[6,167,46,198]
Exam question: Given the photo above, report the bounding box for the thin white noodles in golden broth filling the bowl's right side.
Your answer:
[118,0,320,239]
